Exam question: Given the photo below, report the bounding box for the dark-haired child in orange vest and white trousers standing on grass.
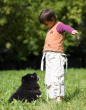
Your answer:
[39,9,78,101]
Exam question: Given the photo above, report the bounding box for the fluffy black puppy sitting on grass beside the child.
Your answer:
[9,73,41,102]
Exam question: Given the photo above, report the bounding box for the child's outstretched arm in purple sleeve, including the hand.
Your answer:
[56,23,78,35]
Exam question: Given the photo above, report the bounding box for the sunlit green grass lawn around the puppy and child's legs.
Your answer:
[0,69,86,110]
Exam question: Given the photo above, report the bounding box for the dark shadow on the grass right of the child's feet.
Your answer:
[63,88,81,102]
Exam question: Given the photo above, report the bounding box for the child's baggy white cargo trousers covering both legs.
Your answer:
[45,52,67,99]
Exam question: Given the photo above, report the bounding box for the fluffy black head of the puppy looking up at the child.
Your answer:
[22,73,39,83]
